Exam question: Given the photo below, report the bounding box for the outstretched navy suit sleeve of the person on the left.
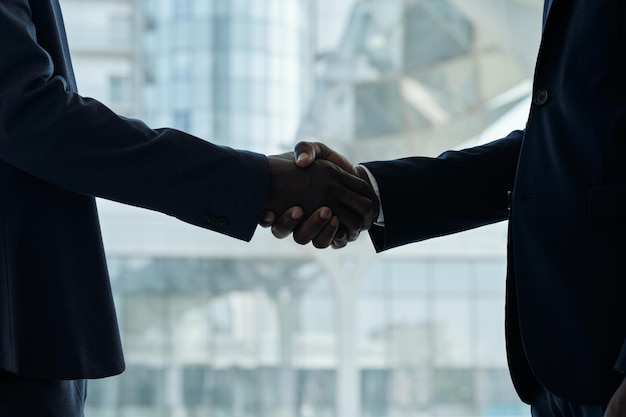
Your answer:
[0,0,269,240]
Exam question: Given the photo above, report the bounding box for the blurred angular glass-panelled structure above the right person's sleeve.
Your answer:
[298,0,542,161]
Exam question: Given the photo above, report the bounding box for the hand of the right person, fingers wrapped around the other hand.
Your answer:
[261,142,378,249]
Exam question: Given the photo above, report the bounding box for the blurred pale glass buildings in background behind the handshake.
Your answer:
[61,0,542,417]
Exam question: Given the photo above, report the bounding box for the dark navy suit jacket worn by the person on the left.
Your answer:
[0,0,268,379]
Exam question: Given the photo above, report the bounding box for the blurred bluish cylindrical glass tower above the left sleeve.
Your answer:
[142,0,313,152]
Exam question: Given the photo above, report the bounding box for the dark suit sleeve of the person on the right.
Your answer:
[363,131,523,251]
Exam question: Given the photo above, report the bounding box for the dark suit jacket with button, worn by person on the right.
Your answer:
[366,0,626,404]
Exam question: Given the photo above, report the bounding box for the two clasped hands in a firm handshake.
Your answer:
[259,142,379,249]
